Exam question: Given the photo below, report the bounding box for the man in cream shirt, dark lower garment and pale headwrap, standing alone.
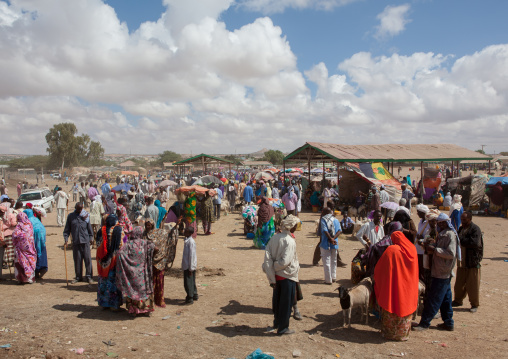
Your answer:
[263,215,300,335]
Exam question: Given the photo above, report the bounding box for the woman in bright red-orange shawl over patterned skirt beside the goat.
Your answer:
[374,232,418,340]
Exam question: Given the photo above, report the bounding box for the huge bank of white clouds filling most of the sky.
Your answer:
[0,0,508,154]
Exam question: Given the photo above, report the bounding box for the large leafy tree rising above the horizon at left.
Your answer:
[46,123,104,168]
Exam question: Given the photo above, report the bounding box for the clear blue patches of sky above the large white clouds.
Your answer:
[105,0,508,71]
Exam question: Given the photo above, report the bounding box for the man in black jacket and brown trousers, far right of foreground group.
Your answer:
[452,211,483,313]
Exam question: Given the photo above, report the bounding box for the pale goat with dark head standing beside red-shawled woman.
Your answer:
[337,277,372,328]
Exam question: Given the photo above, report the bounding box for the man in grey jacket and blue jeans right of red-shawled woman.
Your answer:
[413,213,460,331]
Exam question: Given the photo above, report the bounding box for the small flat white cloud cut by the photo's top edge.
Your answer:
[238,0,360,14]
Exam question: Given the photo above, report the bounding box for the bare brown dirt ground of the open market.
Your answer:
[0,175,508,359]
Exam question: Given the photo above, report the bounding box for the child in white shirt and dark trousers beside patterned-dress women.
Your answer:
[182,227,198,304]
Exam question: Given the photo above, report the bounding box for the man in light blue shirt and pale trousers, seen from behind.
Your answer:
[319,207,341,285]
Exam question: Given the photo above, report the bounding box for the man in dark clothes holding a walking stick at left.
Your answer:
[63,202,93,284]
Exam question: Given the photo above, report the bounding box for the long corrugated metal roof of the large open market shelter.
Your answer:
[284,142,492,162]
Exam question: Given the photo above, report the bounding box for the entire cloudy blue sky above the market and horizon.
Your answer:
[0,0,508,154]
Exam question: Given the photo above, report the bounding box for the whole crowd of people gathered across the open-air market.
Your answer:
[0,169,483,340]
